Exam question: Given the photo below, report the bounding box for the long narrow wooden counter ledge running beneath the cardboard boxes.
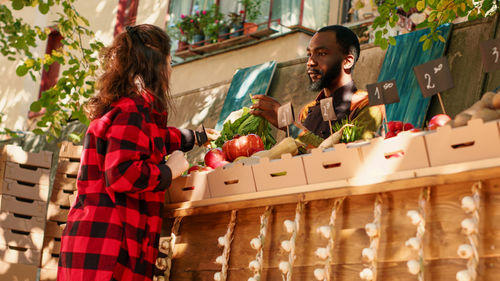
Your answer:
[164,159,500,217]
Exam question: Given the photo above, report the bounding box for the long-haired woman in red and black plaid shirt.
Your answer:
[58,24,210,281]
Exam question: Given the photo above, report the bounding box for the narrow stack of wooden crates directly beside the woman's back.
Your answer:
[40,142,82,281]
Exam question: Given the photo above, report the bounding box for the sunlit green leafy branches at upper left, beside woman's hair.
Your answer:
[0,0,103,141]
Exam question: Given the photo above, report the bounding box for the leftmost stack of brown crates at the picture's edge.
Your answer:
[0,145,52,281]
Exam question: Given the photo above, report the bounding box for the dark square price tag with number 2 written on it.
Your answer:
[413,57,454,98]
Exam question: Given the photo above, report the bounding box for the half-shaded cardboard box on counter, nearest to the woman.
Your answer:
[168,171,210,203]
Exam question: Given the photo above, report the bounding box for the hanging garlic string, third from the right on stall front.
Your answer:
[359,194,382,281]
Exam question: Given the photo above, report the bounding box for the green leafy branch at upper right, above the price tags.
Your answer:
[372,0,498,50]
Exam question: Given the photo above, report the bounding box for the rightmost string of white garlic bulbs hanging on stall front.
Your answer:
[456,181,482,281]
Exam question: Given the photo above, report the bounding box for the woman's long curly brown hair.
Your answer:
[85,24,173,123]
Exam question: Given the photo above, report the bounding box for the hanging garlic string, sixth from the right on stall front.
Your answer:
[248,206,273,281]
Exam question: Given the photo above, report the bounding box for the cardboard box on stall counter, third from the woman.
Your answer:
[252,153,307,191]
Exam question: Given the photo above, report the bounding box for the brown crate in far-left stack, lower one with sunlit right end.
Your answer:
[0,224,43,248]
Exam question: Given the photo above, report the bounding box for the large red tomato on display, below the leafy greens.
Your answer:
[222,134,264,161]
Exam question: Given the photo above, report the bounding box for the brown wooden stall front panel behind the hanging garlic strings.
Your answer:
[166,180,500,280]
